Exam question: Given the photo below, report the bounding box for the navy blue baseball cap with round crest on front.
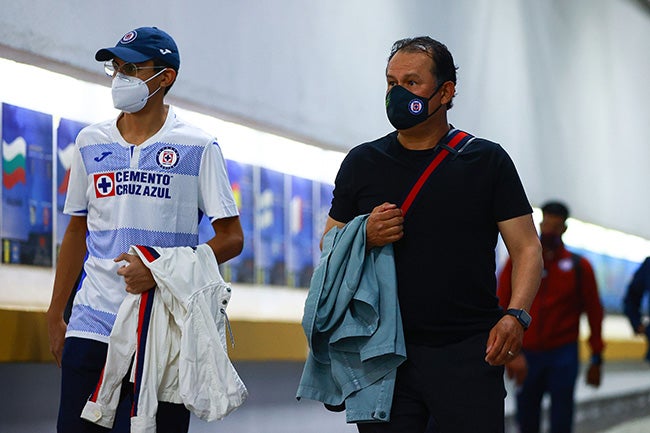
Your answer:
[95,27,181,71]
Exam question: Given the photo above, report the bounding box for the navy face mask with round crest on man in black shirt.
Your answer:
[386,83,444,130]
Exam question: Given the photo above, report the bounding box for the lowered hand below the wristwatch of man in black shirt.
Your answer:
[485,314,524,365]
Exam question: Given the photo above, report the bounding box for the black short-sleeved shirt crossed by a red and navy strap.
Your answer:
[329,131,532,346]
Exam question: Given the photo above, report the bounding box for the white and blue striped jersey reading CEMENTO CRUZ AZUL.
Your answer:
[64,107,238,342]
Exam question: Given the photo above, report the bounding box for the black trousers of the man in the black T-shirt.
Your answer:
[357,334,506,433]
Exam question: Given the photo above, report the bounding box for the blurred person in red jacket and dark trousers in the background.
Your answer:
[497,201,604,433]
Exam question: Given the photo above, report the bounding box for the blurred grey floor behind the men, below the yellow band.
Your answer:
[0,361,650,433]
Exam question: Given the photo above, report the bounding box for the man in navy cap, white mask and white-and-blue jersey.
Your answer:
[47,27,243,433]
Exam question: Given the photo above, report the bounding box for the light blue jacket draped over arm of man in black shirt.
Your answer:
[296,215,406,423]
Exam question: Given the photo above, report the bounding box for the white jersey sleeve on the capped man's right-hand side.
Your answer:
[199,140,239,222]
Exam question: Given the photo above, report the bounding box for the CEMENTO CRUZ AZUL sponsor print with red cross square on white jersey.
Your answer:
[93,170,173,200]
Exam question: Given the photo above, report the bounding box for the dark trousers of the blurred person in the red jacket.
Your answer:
[517,343,578,433]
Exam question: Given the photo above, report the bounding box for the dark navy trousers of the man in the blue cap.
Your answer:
[57,338,190,433]
